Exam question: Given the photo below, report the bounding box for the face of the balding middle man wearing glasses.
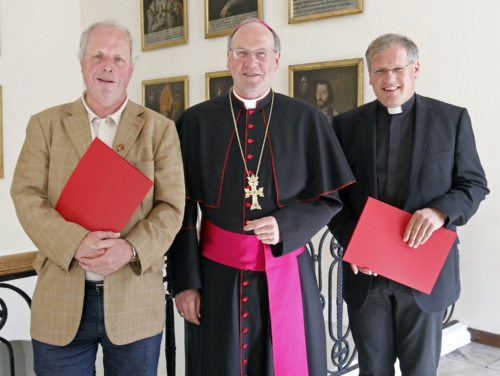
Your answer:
[227,22,280,99]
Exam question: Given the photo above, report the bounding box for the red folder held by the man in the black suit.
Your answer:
[343,197,457,294]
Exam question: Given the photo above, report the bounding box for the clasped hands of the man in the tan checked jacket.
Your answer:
[75,231,133,276]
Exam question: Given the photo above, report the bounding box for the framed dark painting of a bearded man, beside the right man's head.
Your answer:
[288,58,363,120]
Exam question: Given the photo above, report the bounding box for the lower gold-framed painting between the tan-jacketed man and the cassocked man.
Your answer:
[142,76,188,121]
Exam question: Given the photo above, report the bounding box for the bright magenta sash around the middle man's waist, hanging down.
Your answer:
[201,220,309,376]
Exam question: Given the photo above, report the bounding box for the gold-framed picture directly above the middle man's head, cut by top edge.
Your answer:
[205,0,262,38]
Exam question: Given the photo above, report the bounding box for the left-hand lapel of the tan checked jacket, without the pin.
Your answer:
[62,98,92,158]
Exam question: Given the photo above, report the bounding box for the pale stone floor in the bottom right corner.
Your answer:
[438,343,500,376]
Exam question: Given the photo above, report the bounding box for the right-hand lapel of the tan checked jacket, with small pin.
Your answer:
[113,100,145,158]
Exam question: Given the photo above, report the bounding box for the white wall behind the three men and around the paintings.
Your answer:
[0,0,500,356]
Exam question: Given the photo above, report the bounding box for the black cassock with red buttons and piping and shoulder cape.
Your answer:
[169,92,354,376]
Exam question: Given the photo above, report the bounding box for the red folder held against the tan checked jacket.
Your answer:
[56,138,153,232]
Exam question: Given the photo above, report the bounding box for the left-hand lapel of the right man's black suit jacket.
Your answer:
[360,101,378,198]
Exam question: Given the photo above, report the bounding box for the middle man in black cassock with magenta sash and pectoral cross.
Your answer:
[169,19,354,376]
